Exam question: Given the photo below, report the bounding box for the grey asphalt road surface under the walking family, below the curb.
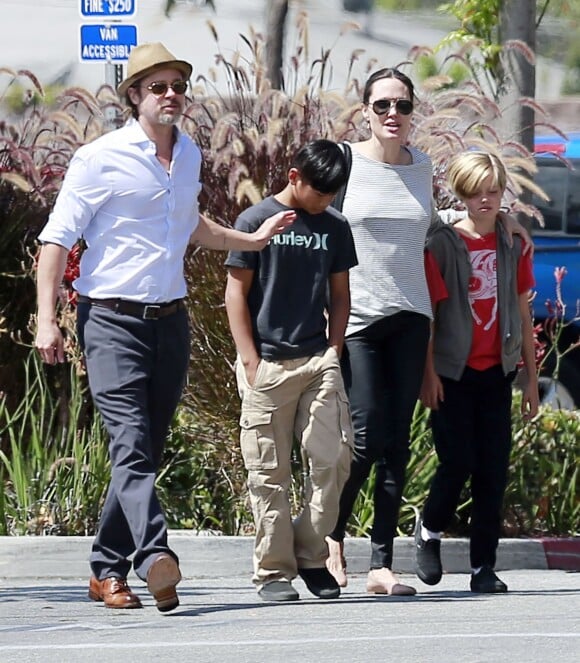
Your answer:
[0,570,580,663]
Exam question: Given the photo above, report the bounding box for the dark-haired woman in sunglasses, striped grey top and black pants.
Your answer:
[327,69,456,596]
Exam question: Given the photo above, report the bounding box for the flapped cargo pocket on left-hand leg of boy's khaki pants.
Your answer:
[240,411,278,470]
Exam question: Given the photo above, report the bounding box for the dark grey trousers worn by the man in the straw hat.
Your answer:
[78,303,189,580]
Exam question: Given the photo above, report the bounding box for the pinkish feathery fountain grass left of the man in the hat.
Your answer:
[0,79,119,407]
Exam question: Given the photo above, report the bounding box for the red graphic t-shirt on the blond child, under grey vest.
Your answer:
[425,232,535,371]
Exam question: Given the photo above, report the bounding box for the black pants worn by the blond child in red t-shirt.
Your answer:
[423,366,513,568]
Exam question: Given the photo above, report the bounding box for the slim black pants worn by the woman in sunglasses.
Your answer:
[331,312,429,569]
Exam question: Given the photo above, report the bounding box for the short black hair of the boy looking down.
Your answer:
[290,138,348,193]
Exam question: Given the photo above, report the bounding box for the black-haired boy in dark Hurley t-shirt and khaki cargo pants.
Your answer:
[226,140,357,601]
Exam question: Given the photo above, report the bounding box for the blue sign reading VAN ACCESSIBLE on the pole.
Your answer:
[81,23,137,62]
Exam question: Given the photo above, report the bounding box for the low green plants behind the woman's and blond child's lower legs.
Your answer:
[348,391,580,536]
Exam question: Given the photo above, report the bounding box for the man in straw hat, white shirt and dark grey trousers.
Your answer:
[36,43,294,612]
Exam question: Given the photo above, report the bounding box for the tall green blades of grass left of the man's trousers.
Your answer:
[0,352,109,534]
